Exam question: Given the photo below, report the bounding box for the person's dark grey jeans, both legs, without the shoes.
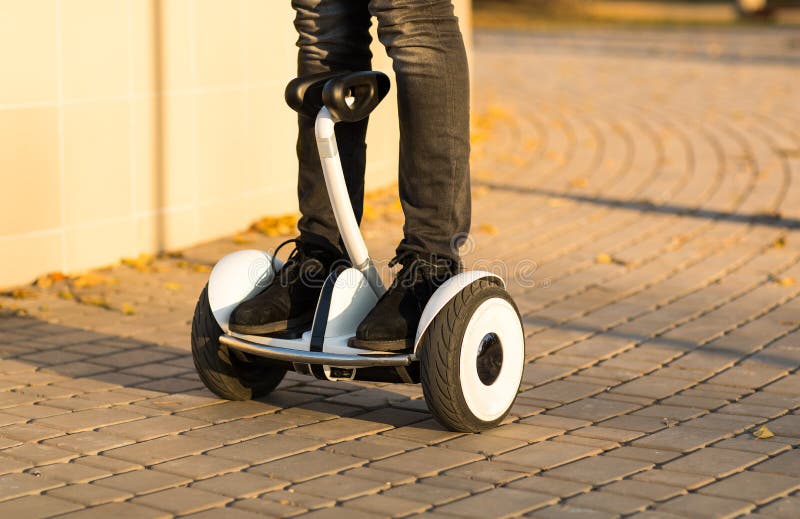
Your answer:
[292,0,470,259]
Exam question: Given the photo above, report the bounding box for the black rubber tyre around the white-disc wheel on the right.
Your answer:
[417,278,521,432]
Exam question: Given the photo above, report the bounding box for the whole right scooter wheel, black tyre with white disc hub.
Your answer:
[417,278,525,432]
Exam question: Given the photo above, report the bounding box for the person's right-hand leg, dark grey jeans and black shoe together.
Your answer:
[351,0,470,351]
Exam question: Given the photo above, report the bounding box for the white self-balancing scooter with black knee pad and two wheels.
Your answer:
[192,72,525,431]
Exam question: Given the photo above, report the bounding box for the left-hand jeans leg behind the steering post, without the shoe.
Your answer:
[292,0,372,254]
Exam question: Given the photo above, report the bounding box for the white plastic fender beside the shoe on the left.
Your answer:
[208,250,283,333]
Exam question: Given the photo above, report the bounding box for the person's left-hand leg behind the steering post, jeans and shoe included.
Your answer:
[230,0,372,335]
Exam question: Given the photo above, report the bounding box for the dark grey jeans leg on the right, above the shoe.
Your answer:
[370,0,470,259]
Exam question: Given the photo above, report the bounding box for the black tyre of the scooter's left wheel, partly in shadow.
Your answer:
[192,285,286,400]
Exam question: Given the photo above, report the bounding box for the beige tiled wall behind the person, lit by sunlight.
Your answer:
[0,0,469,287]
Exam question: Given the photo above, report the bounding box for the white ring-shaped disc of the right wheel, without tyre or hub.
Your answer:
[459,297,525,422]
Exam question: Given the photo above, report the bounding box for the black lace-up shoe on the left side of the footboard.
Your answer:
[230,238,345,335]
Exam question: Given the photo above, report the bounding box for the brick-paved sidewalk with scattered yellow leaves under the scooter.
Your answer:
[0,29,800,519]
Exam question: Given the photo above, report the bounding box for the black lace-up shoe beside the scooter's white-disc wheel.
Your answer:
[349,251,461,351]
